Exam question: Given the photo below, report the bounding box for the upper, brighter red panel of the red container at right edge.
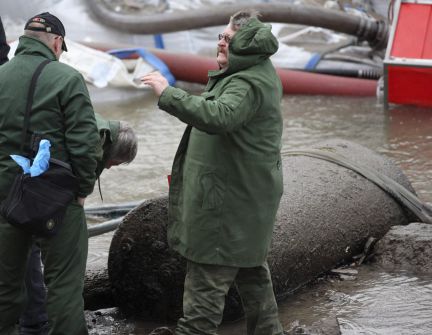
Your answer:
[390,3,432,59]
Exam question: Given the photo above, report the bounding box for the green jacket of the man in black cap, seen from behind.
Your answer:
[0,36,101,200]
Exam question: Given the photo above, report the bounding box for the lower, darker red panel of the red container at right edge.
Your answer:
[387,66,432,106]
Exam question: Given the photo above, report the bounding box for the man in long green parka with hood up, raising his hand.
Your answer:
[142,7,283,335]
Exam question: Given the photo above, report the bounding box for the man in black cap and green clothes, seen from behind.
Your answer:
[0,13,101,335]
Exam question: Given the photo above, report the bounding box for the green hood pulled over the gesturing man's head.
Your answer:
[209,18,279,77]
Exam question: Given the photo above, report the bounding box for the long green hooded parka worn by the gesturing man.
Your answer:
[159,19,283,267]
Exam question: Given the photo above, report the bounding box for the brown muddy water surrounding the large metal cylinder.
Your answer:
[87,92,432,335]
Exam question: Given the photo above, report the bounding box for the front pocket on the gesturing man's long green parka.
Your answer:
[200,172,226,210]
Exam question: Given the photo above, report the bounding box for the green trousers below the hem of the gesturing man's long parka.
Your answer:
[175,261,283,335]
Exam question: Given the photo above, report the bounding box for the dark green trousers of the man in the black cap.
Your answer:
[0,202,88,335]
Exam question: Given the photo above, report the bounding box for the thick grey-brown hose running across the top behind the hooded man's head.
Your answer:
[87,0,388,49]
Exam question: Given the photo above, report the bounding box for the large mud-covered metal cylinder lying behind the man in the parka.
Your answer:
[108,141,413,319]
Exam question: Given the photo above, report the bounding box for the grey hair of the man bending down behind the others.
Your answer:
[108,121,138,164]
